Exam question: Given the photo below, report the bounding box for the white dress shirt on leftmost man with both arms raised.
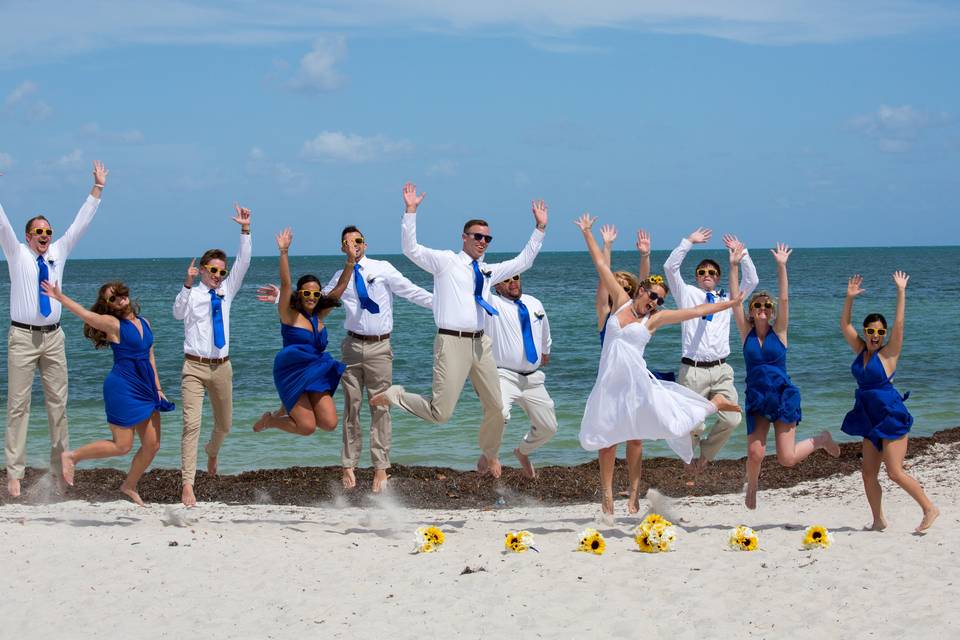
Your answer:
[0,196,100,326]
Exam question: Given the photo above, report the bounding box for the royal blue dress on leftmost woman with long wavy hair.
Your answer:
[103,316,175,428]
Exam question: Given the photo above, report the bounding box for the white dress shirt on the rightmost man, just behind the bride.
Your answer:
[663,238,760,362]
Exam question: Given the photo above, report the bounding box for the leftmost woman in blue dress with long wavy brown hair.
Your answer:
[43,282,174,506]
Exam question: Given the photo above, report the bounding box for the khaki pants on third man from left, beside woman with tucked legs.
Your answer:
[340,335,393,469]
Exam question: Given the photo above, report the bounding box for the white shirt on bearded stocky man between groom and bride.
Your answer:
[492,293,552,373]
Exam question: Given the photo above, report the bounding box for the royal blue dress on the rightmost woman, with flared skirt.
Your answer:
[840,349,913,451]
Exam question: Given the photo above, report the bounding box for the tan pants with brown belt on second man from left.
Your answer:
[180,360,233,485]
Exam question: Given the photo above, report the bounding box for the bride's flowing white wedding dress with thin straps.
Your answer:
[580,302,716,462]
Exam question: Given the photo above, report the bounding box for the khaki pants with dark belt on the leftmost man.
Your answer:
[6,326,70,479]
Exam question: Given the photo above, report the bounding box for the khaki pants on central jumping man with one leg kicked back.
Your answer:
[397,333,504,460]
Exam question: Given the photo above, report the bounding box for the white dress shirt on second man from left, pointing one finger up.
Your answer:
[173,233,253,358]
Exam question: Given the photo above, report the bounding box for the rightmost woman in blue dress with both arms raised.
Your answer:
[840,271,940,533]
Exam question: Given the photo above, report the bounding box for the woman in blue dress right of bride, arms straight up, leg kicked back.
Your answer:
[728,242,840,509]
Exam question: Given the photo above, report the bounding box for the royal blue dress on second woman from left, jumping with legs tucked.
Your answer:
[273,314,347,413]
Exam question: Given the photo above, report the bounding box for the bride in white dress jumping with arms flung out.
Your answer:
[574,213,743,524]
